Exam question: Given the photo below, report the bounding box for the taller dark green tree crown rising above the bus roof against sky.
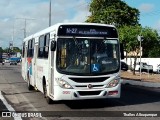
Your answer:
[86,0,139,26]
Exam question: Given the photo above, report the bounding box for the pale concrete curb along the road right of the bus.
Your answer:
[121,79,160,88]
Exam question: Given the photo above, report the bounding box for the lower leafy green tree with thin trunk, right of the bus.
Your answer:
[119,26,160,74]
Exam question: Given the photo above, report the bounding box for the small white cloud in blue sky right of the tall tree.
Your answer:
[139,3,155,13]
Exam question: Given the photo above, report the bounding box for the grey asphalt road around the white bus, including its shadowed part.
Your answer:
[0,64,160,120]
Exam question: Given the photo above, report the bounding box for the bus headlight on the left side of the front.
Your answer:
[56,78,73,89]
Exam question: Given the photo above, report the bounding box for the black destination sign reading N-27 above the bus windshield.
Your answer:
[58,25,118,38]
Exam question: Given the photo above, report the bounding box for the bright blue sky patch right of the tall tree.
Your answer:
[123,0,160,29]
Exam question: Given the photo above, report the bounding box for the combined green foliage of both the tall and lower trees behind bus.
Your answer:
[86,0,160,74]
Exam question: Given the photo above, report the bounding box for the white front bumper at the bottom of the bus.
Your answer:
[54,84,121,100]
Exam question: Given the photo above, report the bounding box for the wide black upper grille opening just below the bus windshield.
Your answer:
[69,77,109,83]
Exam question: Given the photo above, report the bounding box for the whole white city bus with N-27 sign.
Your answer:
[22,23,123,104]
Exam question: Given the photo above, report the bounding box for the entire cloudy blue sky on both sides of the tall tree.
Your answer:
[0,0,160,48]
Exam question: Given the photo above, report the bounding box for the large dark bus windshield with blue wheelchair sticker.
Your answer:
[56,38,120,75]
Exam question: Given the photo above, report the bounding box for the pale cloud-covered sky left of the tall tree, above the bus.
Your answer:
[0,0,89,48]
